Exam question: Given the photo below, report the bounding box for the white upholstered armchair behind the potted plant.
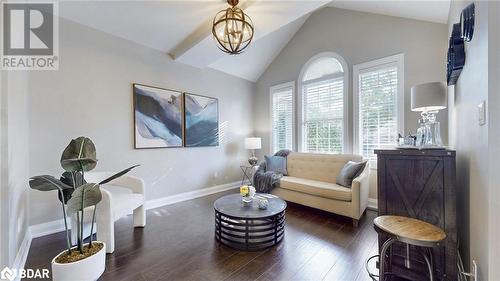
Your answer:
[71,172,146,253]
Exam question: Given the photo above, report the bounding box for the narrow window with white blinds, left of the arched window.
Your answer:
[271,86,294,153]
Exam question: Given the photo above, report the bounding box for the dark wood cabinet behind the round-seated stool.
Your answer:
[375,149,457,281]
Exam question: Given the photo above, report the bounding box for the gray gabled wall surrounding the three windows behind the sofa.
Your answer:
[254,8,447,198]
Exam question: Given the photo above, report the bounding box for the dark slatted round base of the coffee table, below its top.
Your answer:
[215,210,285,251]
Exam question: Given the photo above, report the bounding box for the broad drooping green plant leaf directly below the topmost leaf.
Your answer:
[67,183,102,216]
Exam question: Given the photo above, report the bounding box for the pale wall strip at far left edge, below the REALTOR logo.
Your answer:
[0,71,29,268]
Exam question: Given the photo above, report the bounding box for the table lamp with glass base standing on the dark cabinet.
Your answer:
[411,82,447,145]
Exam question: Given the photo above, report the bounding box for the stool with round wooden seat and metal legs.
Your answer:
[373,216,446,281]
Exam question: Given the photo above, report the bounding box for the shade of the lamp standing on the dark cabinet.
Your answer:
[411,82,447,111]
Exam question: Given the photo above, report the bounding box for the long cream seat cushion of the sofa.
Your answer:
[280,176,352,201]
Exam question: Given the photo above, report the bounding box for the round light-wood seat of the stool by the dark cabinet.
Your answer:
[373,216,446,244]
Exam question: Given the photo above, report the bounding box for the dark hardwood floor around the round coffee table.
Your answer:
[26,189,378,281]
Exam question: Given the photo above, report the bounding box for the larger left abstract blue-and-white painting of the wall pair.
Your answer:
[134,84,183,148]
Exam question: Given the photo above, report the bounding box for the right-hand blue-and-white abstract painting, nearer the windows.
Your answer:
[184,94,219,147]
